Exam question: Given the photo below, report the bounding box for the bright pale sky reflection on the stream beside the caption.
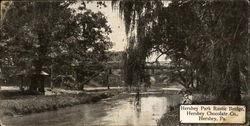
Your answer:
[94,96,179,126]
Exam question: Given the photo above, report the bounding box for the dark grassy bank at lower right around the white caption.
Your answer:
[157,94,250,126]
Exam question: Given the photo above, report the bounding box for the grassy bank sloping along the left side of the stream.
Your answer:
[0,91,120,117]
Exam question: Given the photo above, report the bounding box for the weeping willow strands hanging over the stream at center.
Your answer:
[112,0,163,86]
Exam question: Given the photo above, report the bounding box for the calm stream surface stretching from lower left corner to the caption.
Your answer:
[2,95,180,126]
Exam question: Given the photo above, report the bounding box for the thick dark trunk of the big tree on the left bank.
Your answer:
[30,2,51,93]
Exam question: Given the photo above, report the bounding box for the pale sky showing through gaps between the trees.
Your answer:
[73,1,169,62]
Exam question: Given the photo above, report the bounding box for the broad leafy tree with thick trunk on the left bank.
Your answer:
[1,2,112,92]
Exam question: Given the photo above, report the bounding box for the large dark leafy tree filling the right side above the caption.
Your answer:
[148,0,249,103]
